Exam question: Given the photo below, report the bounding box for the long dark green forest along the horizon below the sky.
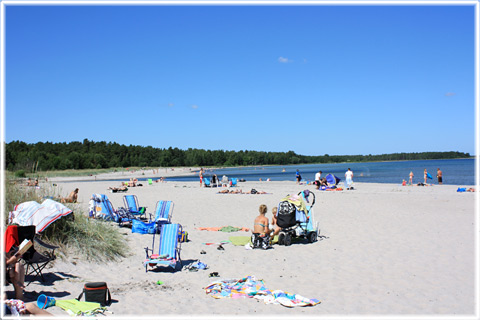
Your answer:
[5,139,470,172]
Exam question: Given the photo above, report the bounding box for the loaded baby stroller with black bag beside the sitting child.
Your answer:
[277,190,318,246]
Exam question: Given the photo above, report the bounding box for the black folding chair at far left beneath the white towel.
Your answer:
[17,226,58,285]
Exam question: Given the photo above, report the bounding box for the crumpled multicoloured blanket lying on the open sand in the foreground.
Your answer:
[205,276,320,308]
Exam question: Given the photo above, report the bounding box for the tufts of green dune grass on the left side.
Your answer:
[4,177,128,261]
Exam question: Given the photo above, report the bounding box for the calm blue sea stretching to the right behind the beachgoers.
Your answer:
[158,159,475,185]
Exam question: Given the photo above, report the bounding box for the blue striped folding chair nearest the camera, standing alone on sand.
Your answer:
[143,223,182,272]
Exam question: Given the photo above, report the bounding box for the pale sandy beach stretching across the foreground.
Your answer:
[6,172,478,319]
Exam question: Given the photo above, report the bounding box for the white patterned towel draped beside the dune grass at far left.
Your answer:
[9,199,72,233]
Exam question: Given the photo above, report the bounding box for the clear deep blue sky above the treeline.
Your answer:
[4,5,475,155]
